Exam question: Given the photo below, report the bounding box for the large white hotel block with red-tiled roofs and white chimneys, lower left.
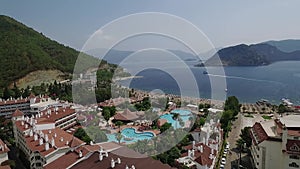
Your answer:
[13,107,85,168]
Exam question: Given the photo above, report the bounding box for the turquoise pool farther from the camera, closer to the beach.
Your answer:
[160,109,192,129]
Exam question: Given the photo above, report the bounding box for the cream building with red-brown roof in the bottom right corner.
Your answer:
[250,115,300,169]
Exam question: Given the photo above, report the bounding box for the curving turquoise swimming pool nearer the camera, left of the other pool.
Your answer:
[106,128,154,143]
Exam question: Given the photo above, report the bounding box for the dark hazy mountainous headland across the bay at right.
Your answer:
[196,40,300,66]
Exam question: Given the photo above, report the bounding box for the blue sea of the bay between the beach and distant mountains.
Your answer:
[110,58,300,105]
